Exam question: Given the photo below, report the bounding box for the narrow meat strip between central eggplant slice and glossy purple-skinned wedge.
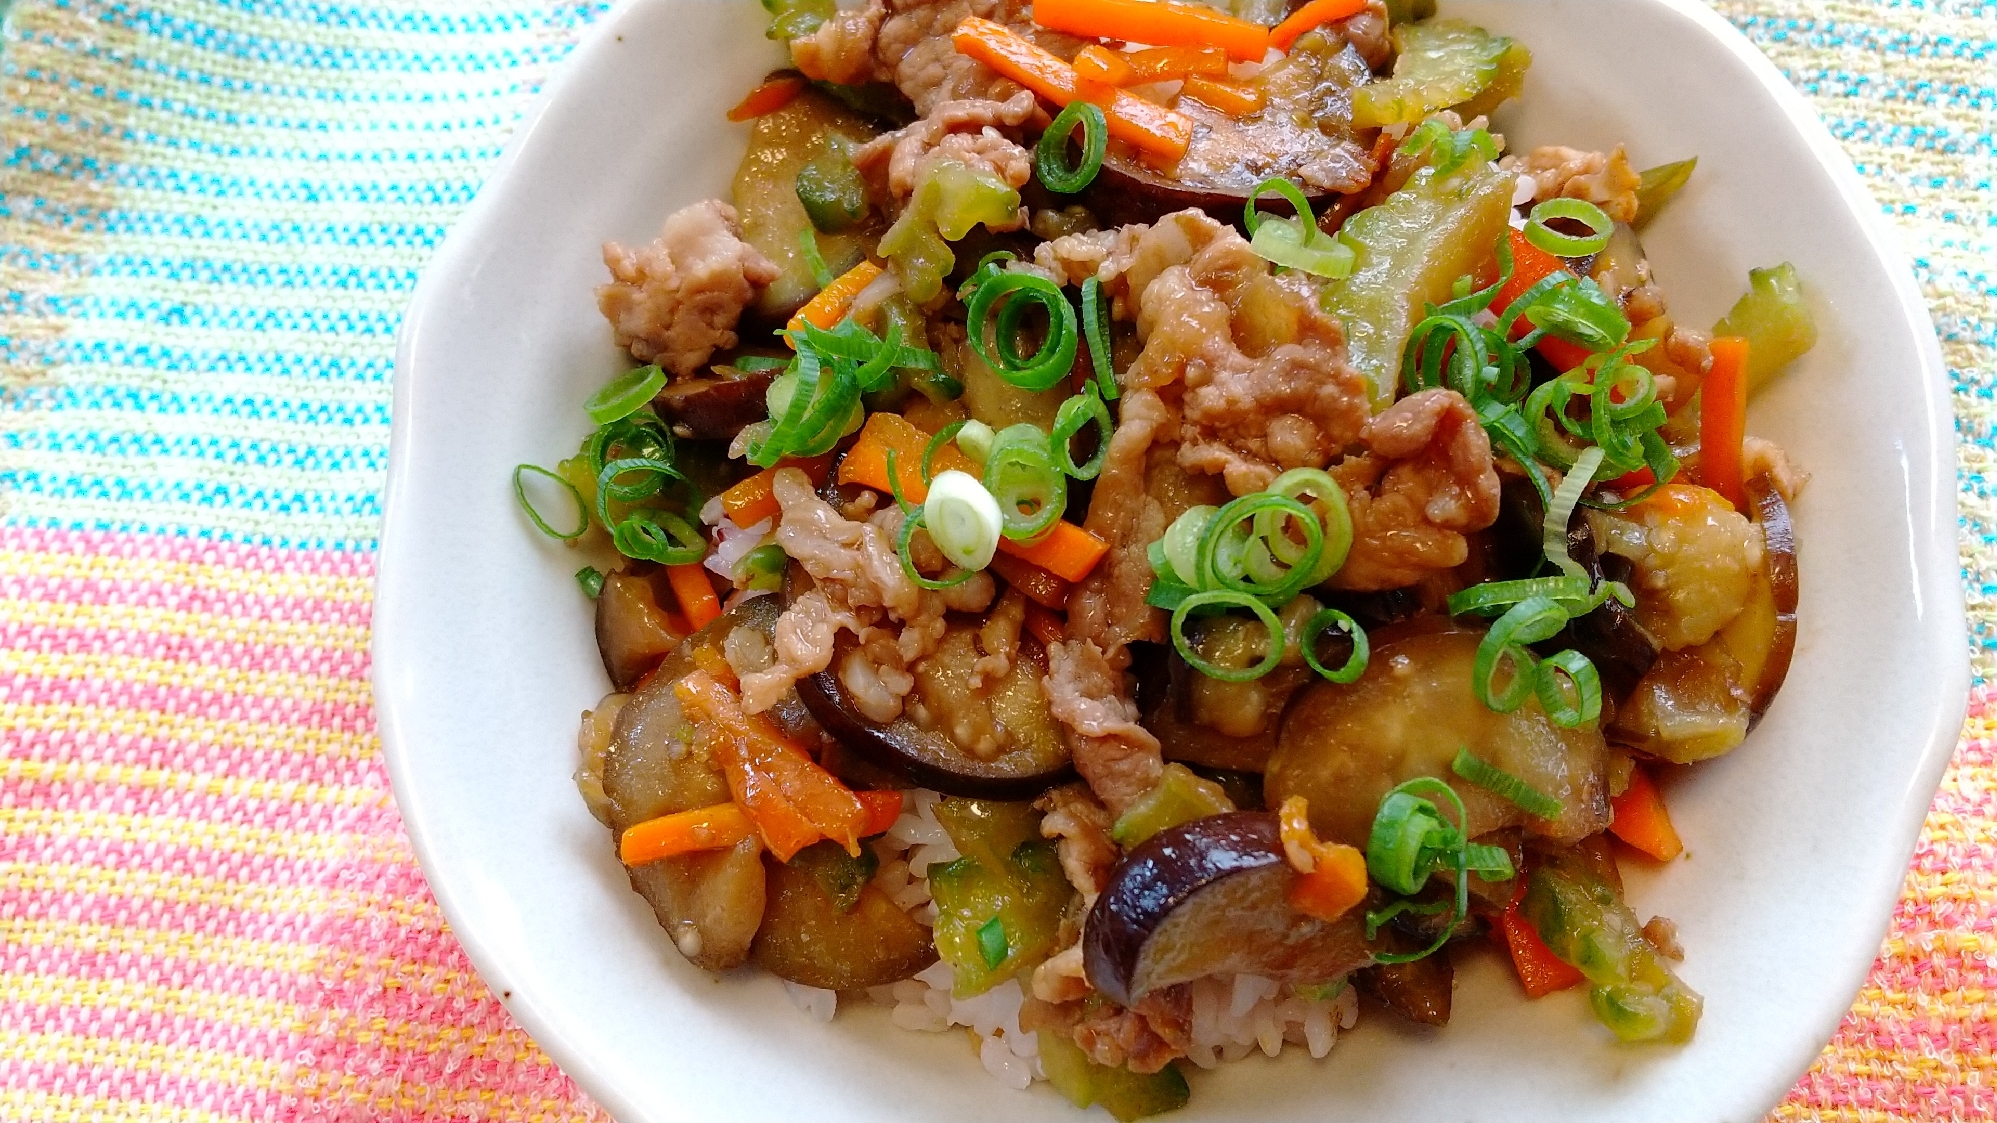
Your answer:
[1042,639,1164,815]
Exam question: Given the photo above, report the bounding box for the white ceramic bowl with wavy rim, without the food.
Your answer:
[373,0,1967,1123]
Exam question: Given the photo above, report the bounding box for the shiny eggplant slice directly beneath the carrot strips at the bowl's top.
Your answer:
[1084,34,1376,226]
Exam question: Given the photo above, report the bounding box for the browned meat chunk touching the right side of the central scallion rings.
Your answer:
[1332,390,1498,591]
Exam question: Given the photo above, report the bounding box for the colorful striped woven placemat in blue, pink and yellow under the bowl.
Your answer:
[0,0,1997,1123]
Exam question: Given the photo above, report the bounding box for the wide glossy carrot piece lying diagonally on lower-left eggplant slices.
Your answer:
[673,671,867,861]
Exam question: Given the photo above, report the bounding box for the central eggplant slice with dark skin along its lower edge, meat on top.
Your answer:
[797,621,1074,799]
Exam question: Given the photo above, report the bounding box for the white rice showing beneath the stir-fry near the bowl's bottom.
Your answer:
[785,789,1358,1089]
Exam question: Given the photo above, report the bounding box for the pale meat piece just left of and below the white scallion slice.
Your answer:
[743,470,995,721]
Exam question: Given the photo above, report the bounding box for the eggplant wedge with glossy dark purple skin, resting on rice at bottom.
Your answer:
[1082,811,1372,1005]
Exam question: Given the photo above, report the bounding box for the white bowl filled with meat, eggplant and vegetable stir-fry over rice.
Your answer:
[377,0,1963,1119]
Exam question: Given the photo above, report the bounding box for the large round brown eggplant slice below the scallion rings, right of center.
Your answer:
[1264,617,1610,847]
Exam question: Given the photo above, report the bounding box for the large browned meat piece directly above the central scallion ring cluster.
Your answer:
[1124,216,1370,496]
